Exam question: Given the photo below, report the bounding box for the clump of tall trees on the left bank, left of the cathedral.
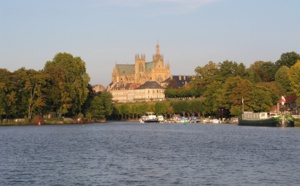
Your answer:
[0,53,112,122]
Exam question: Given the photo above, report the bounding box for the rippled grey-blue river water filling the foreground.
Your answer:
[0,122,300,186]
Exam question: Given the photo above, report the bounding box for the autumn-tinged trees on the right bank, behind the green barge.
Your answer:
[165,52,300,116]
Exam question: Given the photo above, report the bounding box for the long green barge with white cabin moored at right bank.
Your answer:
[238,112,294,127]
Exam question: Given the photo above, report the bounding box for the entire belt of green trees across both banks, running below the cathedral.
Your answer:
[0,52,300,121]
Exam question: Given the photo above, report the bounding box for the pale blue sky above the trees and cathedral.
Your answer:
[0,0,300,86]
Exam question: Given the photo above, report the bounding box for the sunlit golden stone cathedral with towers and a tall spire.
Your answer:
[112,43,170,84]
